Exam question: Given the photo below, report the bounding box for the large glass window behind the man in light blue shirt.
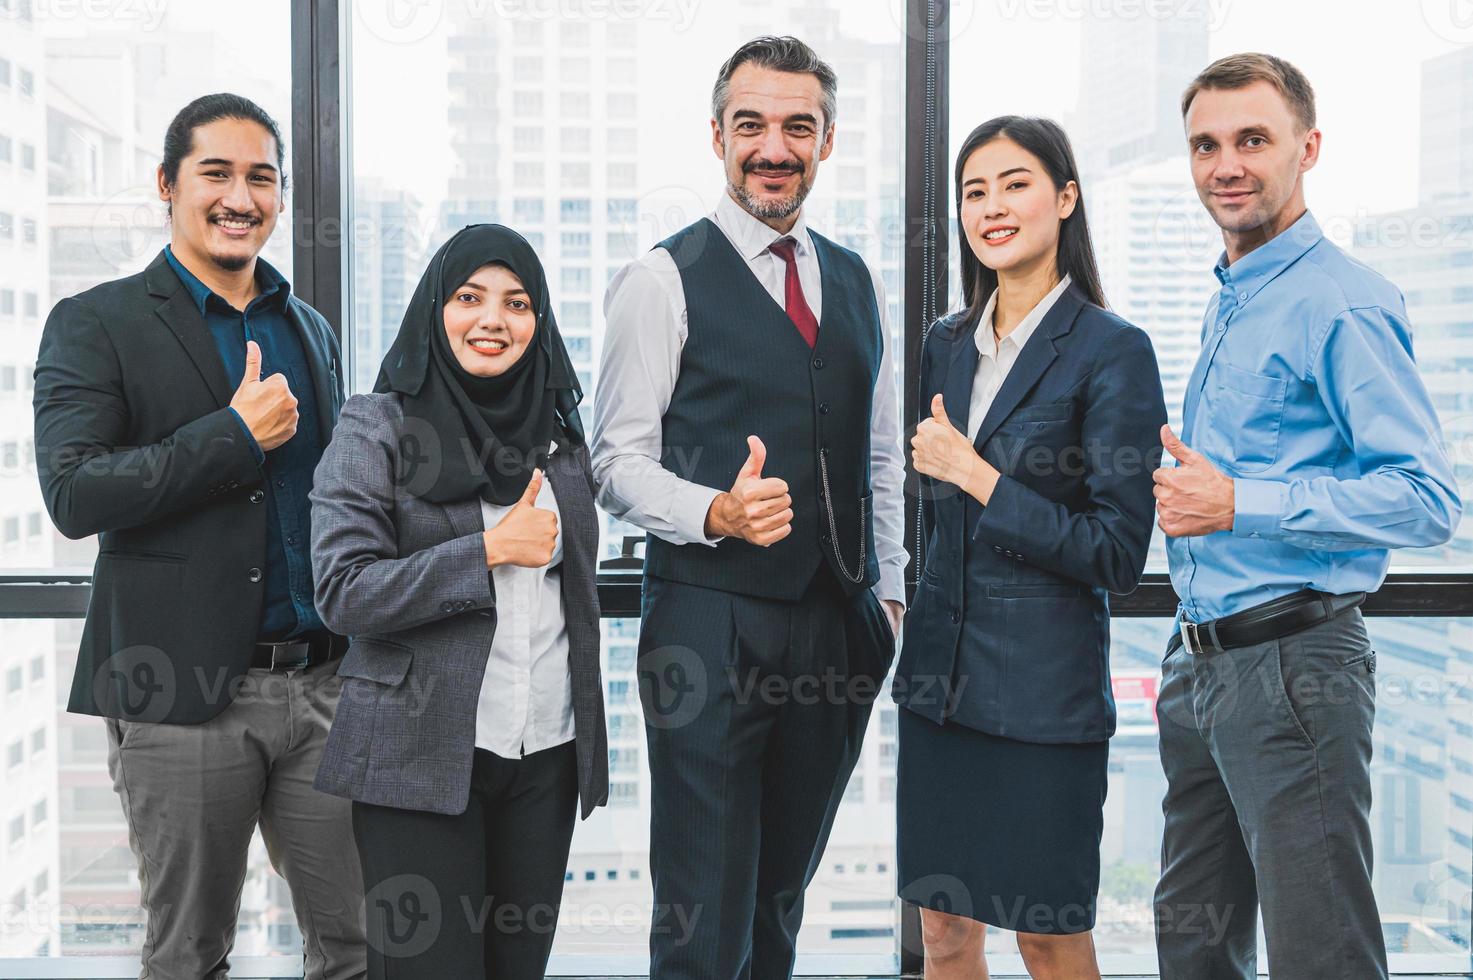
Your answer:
[946,0,1473,970]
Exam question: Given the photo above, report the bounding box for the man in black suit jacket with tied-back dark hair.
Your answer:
[35,94,365,980]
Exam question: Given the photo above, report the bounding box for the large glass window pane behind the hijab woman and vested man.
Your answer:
[349,0,904,962]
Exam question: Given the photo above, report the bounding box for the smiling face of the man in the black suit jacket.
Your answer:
[158,119,283,273]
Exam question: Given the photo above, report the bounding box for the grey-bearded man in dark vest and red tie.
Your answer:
[592,37,904,980]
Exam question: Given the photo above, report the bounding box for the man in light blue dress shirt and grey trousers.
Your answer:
[1155,55,1463,980]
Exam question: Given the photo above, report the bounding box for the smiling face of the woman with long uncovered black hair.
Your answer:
[962,136,1078,276]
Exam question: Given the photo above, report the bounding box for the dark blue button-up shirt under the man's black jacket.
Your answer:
[164,246,323,640]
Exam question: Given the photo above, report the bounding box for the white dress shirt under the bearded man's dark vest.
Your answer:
[591,193,906,603]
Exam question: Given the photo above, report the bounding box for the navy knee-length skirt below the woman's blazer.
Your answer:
[896,707,1109,934]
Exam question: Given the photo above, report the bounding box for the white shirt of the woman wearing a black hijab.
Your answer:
[476,444,574,759]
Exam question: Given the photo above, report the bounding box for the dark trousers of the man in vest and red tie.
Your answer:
[638,569,894,980]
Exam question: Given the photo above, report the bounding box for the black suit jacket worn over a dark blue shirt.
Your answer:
[35,252,343,724]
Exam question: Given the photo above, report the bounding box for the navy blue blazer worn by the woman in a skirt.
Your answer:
[893,286,1167,743]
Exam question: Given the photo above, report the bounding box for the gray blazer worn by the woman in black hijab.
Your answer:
[311,393,608,818]
